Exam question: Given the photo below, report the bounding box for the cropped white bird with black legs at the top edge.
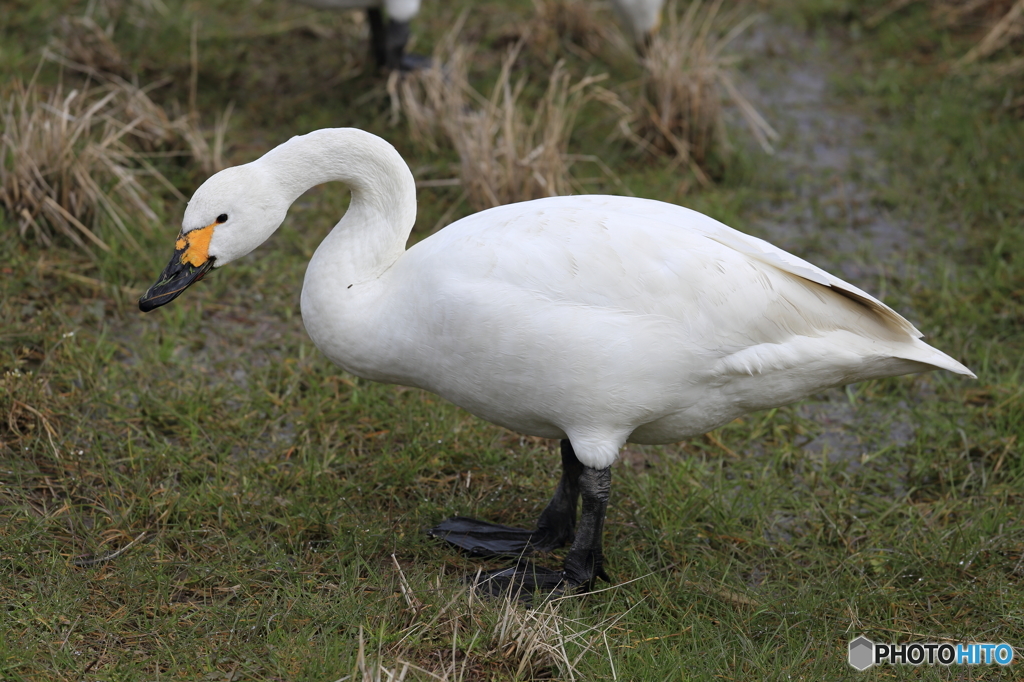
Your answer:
[295,0,430,71]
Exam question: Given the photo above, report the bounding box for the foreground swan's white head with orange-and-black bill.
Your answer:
[138,163,291,312]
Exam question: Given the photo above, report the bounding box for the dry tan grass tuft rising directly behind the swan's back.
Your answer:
[389,35,605,210]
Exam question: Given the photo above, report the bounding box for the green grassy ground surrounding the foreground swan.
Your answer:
[0,0,1024,682]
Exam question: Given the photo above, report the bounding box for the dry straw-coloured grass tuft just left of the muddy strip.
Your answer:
[625,0,777,181]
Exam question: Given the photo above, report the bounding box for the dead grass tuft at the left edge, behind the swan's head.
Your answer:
[0,53,230,252]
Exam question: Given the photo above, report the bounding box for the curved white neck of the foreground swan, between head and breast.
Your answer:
[256,128,416,281]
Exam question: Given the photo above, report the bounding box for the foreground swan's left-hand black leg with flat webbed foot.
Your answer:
[427,439,586,556]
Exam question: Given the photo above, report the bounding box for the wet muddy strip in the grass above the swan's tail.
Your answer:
[735,18,926,284]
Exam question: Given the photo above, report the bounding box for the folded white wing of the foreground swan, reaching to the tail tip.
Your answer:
[407,197,969,374]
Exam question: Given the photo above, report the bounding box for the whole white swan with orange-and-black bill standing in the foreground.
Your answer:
[139,128,974,589]
